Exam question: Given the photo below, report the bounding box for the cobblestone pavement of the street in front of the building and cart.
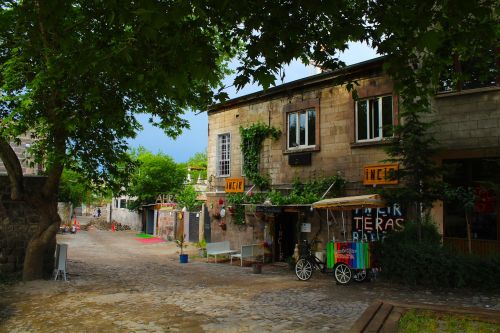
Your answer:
[0,230,500,332]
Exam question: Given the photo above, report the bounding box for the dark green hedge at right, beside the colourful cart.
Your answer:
[374,222,500,289]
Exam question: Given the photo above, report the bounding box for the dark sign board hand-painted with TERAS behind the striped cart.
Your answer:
[352,204,405,242]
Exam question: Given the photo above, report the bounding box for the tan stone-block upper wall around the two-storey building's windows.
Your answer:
[208,76,397,194]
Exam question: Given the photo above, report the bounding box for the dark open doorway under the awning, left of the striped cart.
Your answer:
[273,212,298,261]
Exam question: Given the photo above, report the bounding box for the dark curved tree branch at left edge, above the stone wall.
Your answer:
[0,137,24,200]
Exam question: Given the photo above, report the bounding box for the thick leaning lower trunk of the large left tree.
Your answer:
[23,198,61,281]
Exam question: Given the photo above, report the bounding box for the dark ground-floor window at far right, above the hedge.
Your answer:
[443,158,500,240]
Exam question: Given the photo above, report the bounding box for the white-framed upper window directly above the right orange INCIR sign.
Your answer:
[356,96,393,142]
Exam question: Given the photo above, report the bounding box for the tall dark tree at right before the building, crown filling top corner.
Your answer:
[367,0,499,239]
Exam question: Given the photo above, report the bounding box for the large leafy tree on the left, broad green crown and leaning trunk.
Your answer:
[0,0,233,280]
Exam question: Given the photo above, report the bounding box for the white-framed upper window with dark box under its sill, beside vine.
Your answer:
[287,108,316,149]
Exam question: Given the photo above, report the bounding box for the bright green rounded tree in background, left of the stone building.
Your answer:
[125,148,187,209]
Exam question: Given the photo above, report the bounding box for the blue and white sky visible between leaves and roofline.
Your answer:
[129,43,378,163]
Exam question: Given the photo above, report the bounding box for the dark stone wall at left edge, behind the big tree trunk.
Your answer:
[0,176,45,273]
